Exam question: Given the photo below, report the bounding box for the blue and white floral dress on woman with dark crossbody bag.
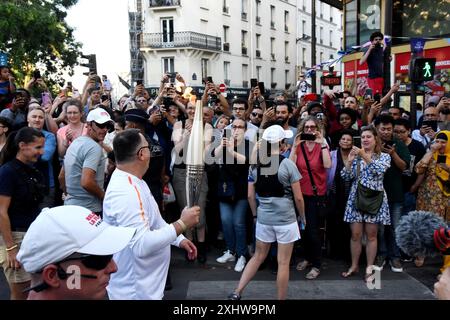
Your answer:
[341,153,391,225]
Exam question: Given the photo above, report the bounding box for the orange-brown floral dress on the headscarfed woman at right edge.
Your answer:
[416,158,450,221]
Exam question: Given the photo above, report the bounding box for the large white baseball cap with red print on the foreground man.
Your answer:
[17,206,136,273]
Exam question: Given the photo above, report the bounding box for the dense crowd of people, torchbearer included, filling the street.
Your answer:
[0,38,450,299]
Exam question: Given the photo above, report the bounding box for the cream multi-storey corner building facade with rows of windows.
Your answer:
[130,0,342,95]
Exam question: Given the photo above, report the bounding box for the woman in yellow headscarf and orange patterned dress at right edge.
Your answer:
[414,130,450,267]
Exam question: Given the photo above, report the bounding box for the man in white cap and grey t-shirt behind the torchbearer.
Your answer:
[59,108,114,216]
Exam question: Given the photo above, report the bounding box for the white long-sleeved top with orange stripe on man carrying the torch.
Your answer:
[103,169,185,300]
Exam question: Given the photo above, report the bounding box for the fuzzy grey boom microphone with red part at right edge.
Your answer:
[395,211,450,257]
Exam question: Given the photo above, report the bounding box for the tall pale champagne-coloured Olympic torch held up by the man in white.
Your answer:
[186,100,204,208]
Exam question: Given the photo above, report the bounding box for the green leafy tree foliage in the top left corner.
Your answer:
[0,0,81,85]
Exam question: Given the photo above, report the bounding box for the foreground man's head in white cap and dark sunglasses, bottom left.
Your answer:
[17,206,136,300]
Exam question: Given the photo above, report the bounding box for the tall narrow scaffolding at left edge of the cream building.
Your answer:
[128,0,144,87]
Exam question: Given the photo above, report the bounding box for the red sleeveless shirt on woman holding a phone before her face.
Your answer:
[296,143,329,196]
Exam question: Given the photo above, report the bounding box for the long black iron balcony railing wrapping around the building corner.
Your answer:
[142,31,222,51]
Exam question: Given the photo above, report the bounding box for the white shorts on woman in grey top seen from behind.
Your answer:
[255,222,300,243]
